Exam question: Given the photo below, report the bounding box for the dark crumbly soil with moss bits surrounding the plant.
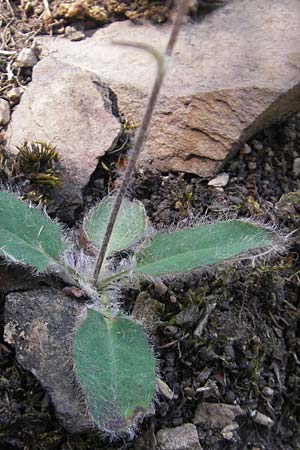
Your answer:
[0,0,300,450]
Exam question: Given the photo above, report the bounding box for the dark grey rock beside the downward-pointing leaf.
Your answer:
[5,288,92,433]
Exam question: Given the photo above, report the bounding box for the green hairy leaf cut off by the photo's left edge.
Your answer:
[0,192,64,271]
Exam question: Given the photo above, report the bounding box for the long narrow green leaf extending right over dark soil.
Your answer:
[134,220,275,275]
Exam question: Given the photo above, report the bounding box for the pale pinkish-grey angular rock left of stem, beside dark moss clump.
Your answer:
[6,57,121,197]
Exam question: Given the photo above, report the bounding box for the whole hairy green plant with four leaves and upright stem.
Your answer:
[0,2,283,434]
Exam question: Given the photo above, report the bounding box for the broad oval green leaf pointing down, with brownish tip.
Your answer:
[73,309,155,433]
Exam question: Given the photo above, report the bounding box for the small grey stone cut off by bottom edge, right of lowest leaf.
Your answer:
[156,423,202,450]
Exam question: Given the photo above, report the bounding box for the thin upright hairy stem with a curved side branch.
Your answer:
[93,0,186,286]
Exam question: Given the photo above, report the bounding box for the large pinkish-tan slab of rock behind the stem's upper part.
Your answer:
[39,0,300,176]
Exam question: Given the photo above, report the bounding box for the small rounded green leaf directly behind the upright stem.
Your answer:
[83,197,145,255]
